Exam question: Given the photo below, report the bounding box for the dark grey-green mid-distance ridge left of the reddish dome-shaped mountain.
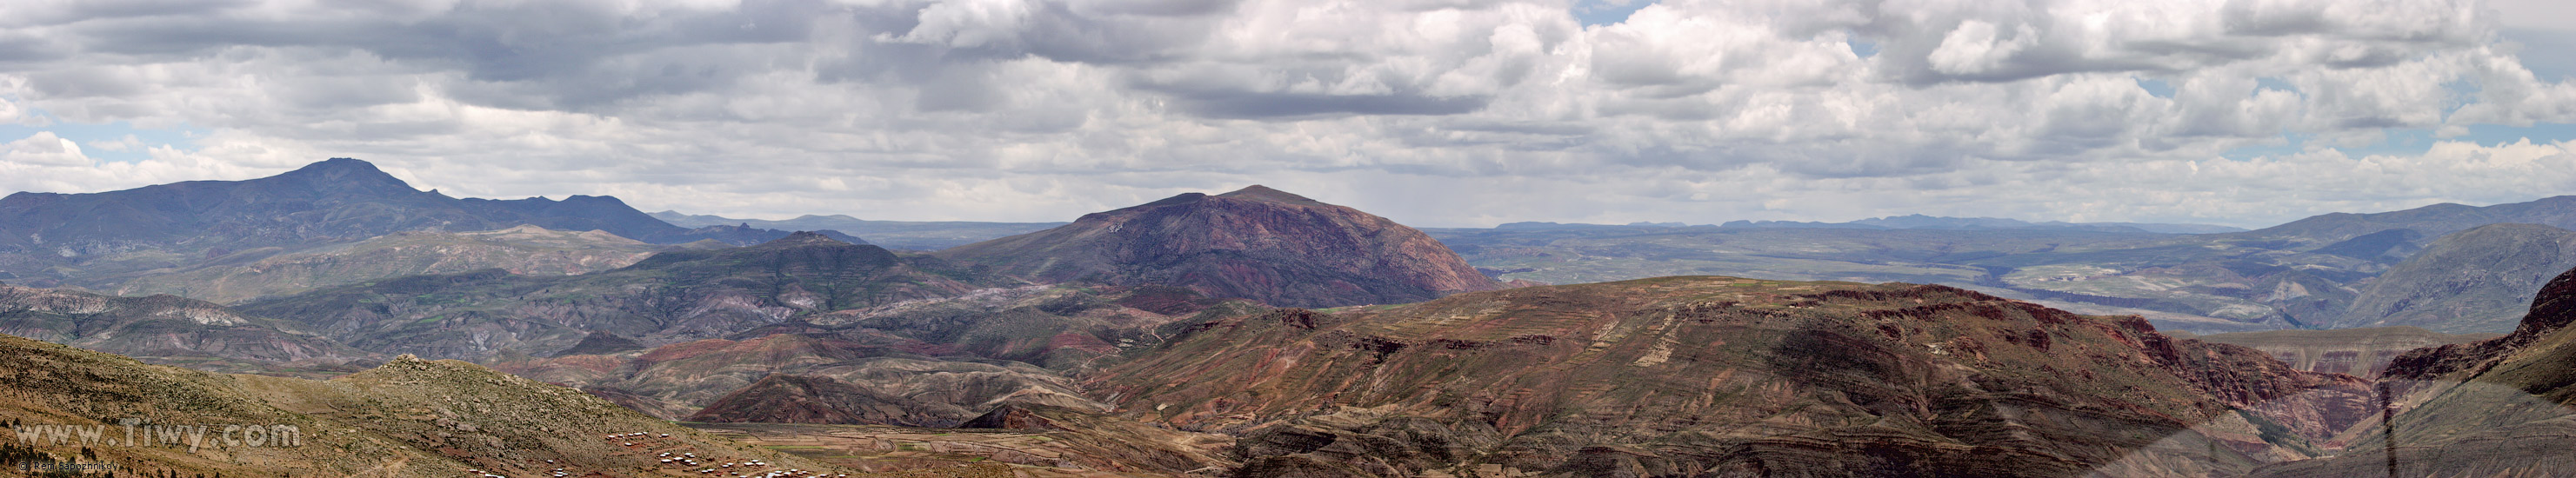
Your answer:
[237,234,1004,360]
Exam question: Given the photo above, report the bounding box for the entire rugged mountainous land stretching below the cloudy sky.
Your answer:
[0,159,2576,478]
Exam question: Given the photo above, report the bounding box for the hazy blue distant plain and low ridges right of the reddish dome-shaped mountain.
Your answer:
[1427,196,2576,334]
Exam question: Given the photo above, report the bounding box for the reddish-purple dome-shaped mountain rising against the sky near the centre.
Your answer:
[938,185,1502,306]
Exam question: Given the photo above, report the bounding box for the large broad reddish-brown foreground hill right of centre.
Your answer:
[1087,277,2367,475]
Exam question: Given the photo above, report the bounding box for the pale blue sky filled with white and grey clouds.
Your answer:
[0,0,2576,226]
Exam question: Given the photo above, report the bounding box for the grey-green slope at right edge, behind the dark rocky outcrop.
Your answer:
[2332,223,2576,334]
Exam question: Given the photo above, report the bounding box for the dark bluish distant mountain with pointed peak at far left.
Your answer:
[0,156,850,288]
